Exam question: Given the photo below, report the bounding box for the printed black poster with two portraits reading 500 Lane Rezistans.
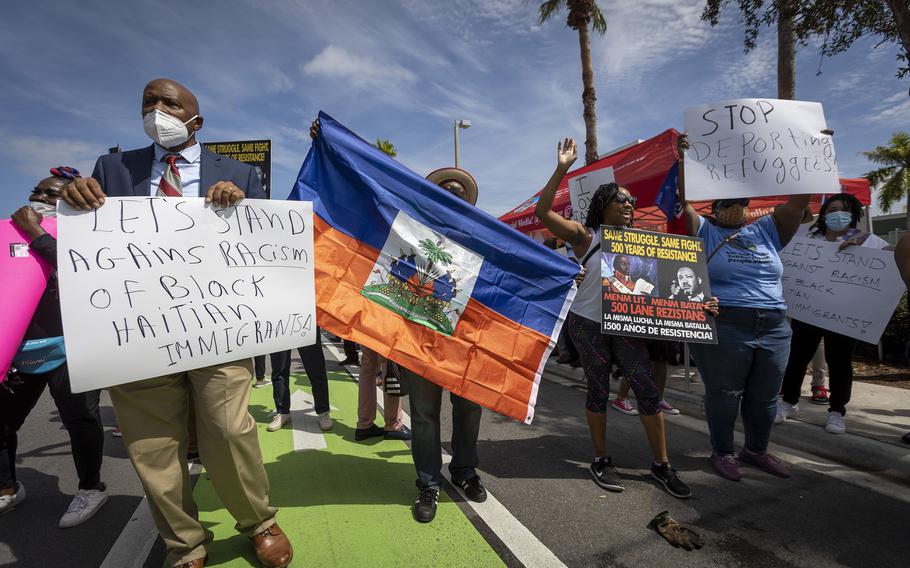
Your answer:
[600,225,717,343]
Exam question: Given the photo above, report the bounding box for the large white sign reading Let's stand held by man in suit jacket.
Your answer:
[57,197,316,392]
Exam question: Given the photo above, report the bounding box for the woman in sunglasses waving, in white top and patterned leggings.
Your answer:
[535,138,712,498]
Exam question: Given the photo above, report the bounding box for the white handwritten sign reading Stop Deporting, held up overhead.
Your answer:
[684,99,840,200]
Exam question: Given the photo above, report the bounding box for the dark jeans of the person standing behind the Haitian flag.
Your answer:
[400,367,483,490]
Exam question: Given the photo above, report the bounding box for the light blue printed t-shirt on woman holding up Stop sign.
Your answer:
[698,215,787,310]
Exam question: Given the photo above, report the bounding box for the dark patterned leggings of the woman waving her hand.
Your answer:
[567,312,660,416]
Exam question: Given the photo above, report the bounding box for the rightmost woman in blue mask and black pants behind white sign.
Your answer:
[774,193,888,434]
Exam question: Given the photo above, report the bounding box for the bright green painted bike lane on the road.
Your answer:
[185,372,504,567]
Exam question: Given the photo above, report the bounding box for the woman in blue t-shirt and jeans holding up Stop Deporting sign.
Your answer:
[679,135,809,481]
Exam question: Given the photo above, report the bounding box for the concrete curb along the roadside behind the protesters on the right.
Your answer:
[543,360,910,487]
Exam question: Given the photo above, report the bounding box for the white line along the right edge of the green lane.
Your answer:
[327,345,566,568]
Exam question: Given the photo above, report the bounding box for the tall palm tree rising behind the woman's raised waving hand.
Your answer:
[537,0,607,164]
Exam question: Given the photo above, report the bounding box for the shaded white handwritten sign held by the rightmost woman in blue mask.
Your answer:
[780,236,905,343]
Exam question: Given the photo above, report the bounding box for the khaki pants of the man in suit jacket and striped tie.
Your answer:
[110,359,276,565]
